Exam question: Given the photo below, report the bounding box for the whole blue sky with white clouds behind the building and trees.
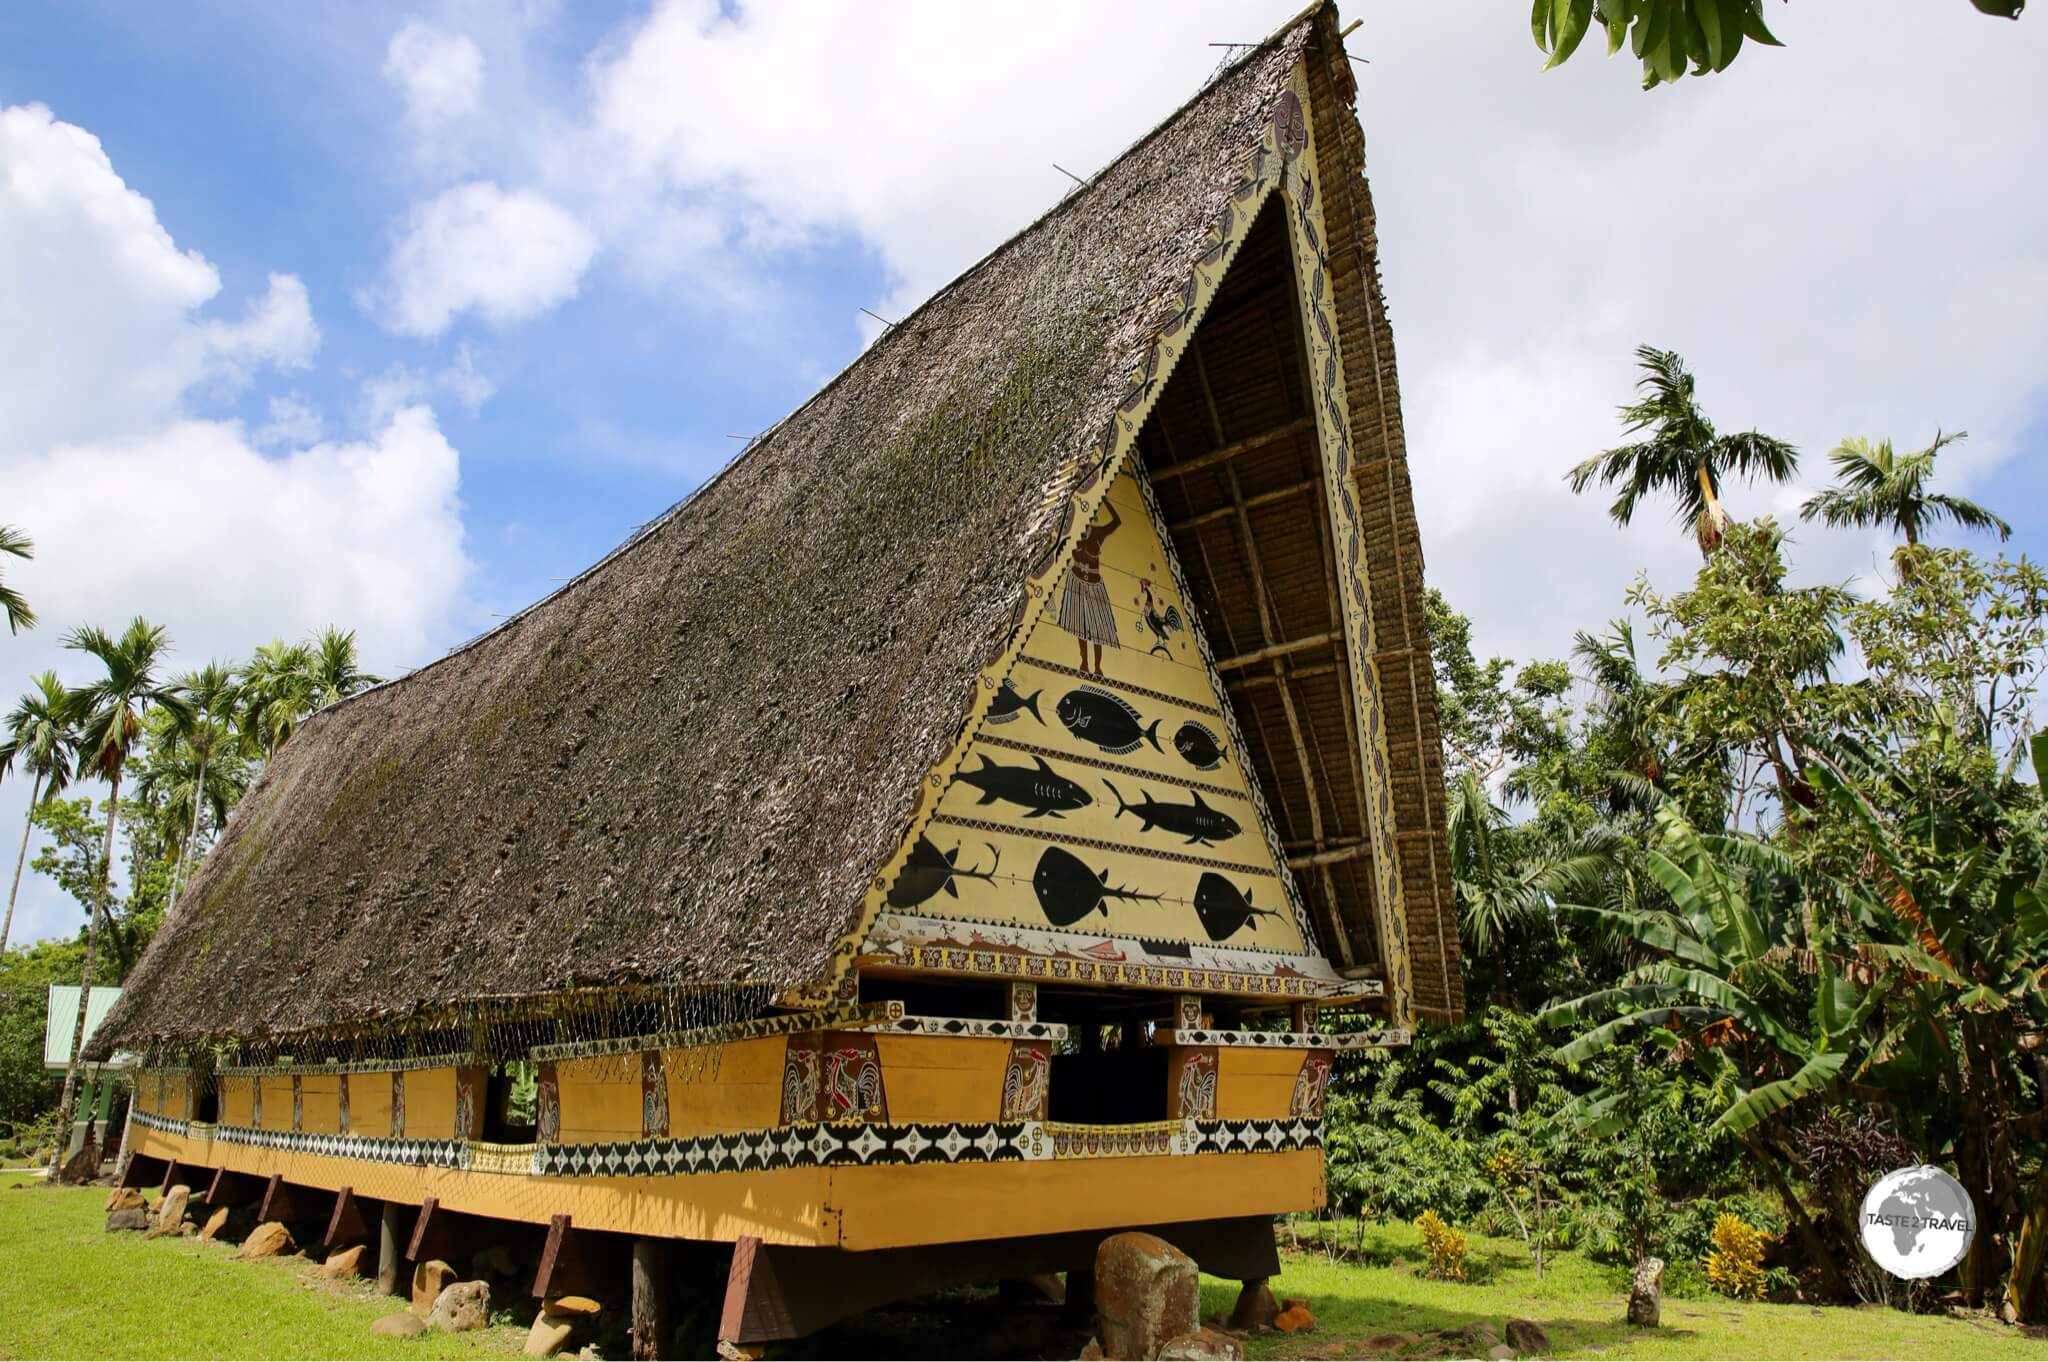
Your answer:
[0,0,2048,938]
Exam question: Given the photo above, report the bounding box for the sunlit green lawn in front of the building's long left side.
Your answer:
[0,1174,526,1358]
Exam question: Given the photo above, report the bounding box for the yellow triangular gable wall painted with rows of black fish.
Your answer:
[874,473,1309,954]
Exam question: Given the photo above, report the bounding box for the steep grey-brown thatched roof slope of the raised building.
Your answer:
[100,8,1456,1047]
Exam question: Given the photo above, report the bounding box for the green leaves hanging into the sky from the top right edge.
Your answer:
[1530,0,2025,90]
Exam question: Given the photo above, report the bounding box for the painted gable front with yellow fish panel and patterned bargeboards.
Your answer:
[840,66,1409,1024]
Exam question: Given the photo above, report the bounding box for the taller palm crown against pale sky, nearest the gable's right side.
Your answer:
[1569,346,1798,557]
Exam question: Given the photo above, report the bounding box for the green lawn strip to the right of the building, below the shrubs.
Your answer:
[1202,1225,2048,1358]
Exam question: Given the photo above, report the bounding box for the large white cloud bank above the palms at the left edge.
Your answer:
[0,107,469,940]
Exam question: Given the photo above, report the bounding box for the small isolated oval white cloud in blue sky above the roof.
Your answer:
[381,180,598,336]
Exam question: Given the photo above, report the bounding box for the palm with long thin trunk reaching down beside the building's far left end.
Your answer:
[49,614,186,1172]
